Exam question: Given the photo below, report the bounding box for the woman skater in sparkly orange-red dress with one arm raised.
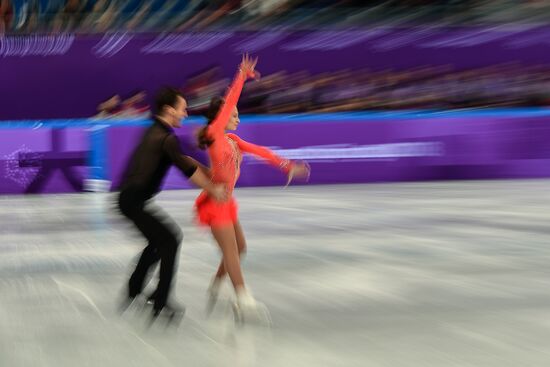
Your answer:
[195,55,309,312]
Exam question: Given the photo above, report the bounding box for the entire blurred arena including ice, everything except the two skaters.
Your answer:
[0,0,550,367]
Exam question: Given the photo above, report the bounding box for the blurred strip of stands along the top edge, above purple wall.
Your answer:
[0,0,550,34]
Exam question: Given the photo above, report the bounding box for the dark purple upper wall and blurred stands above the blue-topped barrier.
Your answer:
[0,0,550,120]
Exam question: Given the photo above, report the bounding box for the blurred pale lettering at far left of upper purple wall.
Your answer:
[0,34,75,57]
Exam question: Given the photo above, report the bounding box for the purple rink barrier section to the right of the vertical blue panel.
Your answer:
[108,114,550,193]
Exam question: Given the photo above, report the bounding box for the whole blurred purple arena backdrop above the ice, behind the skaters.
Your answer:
[0,0,550,193]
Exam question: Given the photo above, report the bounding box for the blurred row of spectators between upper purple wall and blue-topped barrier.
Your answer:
[98,63,550,118]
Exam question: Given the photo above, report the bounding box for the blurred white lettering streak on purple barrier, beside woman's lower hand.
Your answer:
[266,142,445,161]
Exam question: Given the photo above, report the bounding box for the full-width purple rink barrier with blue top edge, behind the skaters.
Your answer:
[0,110,550,193]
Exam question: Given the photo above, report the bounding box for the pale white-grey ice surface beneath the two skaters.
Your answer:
[0,180,550,367]
